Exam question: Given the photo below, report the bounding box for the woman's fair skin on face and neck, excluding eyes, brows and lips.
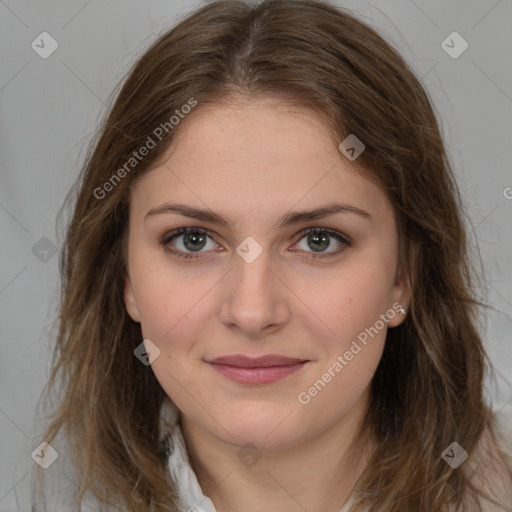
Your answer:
[125,97,409,512]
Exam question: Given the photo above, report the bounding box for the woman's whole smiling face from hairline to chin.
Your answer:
[125,98,408,449]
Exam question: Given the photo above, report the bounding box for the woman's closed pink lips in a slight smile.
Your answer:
[207,355,308,384]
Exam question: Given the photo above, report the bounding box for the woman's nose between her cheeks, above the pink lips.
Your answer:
[220,246,291,339]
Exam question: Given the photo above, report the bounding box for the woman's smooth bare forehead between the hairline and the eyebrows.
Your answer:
[128,99,390,228]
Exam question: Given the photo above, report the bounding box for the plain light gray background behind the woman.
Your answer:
[0,0,512,511]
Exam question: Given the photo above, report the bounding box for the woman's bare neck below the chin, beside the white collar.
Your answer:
[182,396,376,512]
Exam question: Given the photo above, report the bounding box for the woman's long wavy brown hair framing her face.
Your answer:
[33,0,508,512]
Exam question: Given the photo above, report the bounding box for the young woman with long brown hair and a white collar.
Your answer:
[29,0,512,512]
